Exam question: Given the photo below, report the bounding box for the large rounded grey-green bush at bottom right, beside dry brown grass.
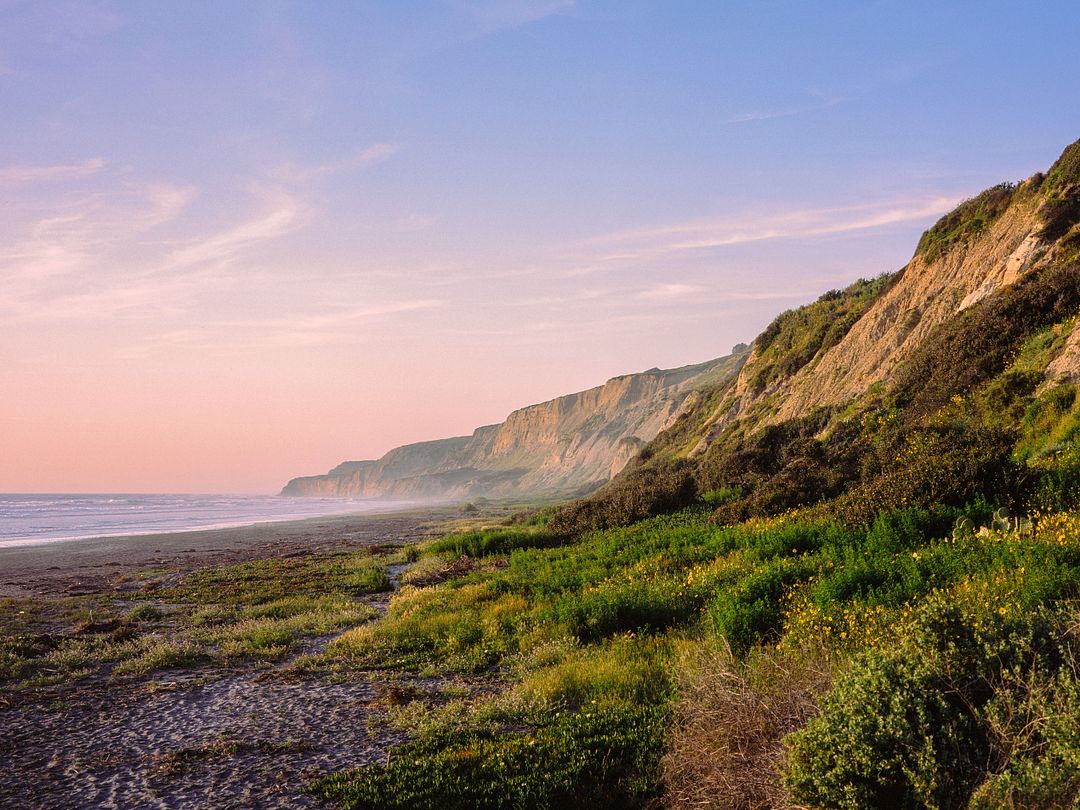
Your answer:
[786,602,1066,808]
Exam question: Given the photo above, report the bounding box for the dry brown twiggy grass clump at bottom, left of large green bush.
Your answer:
[661,646,833,810]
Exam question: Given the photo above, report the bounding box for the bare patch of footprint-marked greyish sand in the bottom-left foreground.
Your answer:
[0,673,401,808]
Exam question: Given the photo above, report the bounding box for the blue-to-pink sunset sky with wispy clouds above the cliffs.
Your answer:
[0,0,1080,492]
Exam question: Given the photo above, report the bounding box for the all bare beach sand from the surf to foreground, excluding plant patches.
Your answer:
[0,509,481,808]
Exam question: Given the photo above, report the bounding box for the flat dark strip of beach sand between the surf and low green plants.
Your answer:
[0,505,460,598]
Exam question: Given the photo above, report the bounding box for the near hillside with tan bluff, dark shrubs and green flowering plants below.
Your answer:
[308,143,1080,809]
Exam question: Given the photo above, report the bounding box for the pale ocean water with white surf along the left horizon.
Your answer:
[0,494,408,548]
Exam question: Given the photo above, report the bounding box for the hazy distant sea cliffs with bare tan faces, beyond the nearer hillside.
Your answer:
[282,354,748,499]
